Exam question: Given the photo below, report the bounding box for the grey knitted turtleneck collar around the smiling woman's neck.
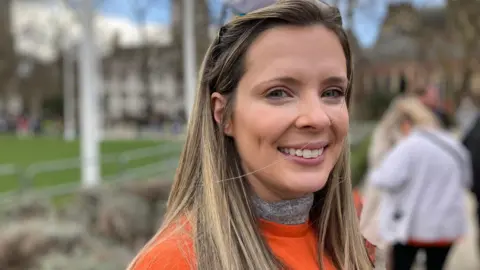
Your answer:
[252,193,313,225]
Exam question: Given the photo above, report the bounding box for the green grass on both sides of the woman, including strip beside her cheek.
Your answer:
[0,132,370,198]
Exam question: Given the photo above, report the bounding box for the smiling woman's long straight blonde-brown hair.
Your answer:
[130,0,371,270]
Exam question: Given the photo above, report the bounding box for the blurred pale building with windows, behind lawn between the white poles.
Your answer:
[103,46,184,120]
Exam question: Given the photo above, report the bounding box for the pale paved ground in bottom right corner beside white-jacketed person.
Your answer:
[447,194,480,270]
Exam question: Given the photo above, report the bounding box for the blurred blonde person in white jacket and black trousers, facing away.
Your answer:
[369,99,472,270]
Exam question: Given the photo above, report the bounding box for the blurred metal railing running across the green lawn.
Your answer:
[0,143,179,203]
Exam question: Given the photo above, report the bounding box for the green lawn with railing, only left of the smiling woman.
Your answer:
[0,136,182,192]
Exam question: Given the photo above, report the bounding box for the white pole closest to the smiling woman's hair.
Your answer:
[183,0,197,119]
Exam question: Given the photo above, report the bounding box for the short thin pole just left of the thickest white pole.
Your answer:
[63,49,76,141]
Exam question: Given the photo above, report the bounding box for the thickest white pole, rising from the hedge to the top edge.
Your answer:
[79,0,100,187]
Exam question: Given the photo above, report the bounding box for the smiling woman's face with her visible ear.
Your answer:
[212,25,349,201]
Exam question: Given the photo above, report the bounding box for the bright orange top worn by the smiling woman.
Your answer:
[129,220,335,270]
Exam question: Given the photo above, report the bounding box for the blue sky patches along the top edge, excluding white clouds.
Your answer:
[99,0,443,47]
